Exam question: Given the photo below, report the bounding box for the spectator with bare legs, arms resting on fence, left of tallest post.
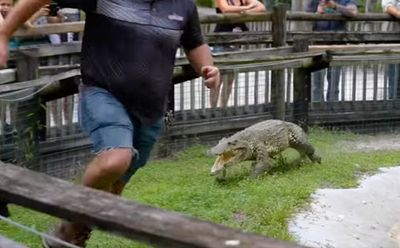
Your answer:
[210,0,265,108]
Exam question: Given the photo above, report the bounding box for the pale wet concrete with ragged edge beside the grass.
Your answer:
[289,167,400,248]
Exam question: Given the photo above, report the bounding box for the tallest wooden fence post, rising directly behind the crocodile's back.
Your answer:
[271,4,289,120]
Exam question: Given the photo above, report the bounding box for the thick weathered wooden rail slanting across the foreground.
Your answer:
[0,163,306,248]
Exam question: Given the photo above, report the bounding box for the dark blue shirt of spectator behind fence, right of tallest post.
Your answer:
[306,0,357,31]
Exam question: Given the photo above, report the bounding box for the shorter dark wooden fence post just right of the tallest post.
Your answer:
[293,39,311,131]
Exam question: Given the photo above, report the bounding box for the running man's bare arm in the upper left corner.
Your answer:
[0,0,50,67]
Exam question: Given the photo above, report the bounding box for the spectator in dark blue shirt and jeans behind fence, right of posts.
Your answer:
[307,0,358,102]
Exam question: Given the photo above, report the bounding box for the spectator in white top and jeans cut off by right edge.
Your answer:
[381,0,400,99]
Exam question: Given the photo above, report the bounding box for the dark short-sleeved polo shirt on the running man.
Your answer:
[56,0,204,124]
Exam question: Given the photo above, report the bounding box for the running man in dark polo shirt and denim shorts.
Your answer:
[0,0,220,247]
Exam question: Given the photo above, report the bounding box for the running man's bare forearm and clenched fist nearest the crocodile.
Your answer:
[185,44,220,89]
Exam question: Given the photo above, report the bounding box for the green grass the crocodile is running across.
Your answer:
[0,129,400,248]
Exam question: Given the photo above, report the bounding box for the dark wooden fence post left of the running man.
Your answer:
[15,50,46,167]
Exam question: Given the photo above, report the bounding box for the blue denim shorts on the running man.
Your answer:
[79,85,164,183]
